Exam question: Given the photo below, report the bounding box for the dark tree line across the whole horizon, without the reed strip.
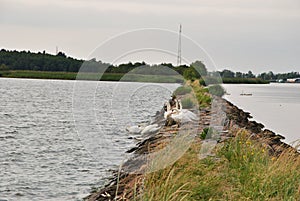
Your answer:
[0,49,300,81]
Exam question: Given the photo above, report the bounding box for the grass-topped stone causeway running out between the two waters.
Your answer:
[86,80,300,201]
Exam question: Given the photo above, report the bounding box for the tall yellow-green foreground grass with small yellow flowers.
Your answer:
[136,130,300,201]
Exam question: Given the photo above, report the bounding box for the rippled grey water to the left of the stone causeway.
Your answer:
[0,78,178,200]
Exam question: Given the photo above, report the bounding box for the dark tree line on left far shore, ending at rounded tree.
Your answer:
[0,49,207,77]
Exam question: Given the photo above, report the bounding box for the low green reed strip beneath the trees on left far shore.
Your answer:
[0,70,183,83]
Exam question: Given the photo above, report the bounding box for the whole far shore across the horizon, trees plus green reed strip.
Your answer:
[0,49,300,84]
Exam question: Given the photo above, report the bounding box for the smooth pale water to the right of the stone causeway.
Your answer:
[223,83,300,146]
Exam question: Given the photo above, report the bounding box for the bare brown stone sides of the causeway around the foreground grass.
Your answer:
[86,97,296,201]
